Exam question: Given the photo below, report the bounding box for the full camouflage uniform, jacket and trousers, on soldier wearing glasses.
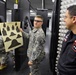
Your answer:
[23,28,45,75]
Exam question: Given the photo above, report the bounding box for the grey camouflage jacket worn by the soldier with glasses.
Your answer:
[23,28,45,61]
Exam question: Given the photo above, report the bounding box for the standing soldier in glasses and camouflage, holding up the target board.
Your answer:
[20,15,45,75]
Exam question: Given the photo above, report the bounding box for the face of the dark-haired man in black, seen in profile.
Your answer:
[64,10,73,30]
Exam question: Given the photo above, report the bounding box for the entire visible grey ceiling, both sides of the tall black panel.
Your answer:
[6,0,54,10]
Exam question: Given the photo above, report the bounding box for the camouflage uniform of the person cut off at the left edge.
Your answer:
[0,35,8,70]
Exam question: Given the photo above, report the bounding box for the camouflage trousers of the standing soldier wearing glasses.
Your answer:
[29,62,41,75]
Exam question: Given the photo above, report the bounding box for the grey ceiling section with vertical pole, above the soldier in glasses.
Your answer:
[30,0,53,10]
